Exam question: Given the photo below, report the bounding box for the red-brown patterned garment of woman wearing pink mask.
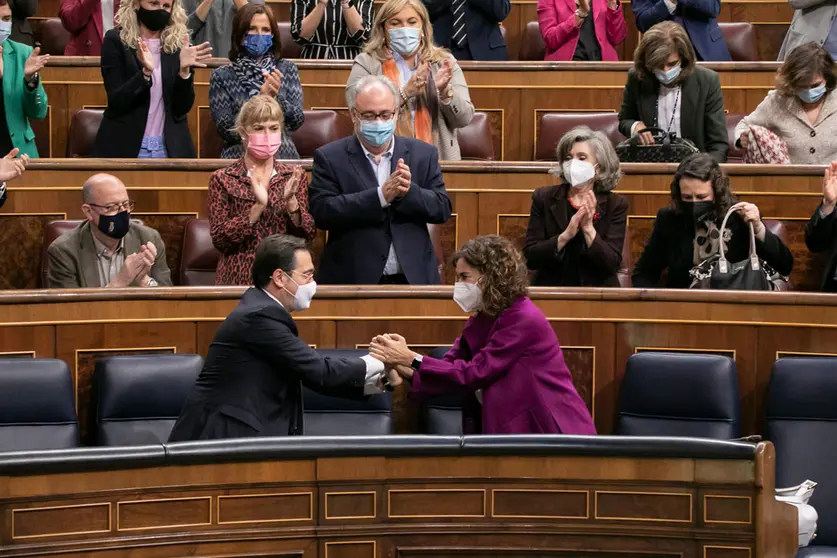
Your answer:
[208,158,317,285]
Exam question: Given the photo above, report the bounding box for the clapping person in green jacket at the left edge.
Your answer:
[0,3,49,158]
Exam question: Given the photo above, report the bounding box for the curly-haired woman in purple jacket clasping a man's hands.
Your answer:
[369,235,596,434]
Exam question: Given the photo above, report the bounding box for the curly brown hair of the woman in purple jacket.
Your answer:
[453,234,529,316]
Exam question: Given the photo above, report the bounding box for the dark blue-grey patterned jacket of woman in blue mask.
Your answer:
[209,58,305,159]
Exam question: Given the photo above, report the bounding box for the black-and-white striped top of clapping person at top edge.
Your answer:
[291,0,372,60]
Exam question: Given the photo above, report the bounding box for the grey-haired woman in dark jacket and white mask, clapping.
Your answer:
[523,126,628,287]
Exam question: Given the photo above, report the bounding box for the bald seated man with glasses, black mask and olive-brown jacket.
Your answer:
[47,174,171,289]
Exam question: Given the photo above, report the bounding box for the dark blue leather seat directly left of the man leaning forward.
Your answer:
[91,354,203,446]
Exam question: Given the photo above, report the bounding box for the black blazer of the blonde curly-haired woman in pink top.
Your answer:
[93,29,197,159]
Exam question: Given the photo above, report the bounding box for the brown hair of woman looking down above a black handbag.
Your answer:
[634,21,697,83]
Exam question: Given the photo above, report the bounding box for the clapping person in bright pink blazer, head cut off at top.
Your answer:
[538,0,628,62]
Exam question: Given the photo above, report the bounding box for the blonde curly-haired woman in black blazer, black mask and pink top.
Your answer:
[93,0,212,159]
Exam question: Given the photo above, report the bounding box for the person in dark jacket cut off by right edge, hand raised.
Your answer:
[805,162,837,293]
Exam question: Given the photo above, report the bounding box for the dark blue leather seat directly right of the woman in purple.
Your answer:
[617,352,740,440]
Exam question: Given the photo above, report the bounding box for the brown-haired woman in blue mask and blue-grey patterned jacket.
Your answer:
[209,4,305,159]
